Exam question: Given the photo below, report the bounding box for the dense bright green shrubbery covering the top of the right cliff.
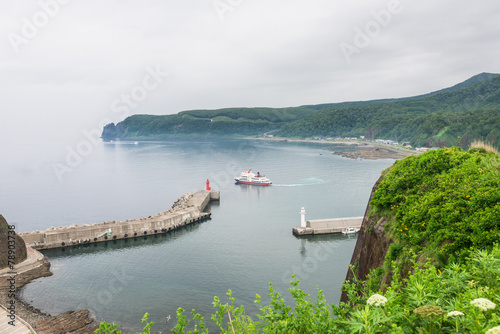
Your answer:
[371,148,500,266]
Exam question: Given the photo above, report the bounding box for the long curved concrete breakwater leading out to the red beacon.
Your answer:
[20,190,220,249]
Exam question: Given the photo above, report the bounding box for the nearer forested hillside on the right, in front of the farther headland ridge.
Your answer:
[278,76,500,146]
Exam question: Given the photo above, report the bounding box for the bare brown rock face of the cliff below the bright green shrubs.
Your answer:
[340,177,393,302]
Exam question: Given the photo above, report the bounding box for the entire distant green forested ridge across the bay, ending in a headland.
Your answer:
[102,73,500,147]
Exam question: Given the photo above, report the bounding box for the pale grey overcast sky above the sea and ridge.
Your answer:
[0,0,500,145]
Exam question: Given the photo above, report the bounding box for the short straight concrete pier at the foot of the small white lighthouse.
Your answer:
[292,217,363,236]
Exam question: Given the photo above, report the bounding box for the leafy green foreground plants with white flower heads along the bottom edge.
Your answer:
[96,245,500,334]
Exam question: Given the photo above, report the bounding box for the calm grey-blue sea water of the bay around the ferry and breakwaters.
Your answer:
[0,140,393,333]
